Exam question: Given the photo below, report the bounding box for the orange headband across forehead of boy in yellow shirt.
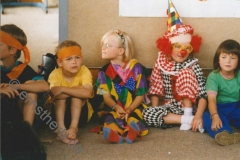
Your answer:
[57,46,82,60]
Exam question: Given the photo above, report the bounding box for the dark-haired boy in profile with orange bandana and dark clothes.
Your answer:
[0,24,49,125]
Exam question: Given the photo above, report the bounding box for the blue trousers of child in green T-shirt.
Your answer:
[203,101,240,138]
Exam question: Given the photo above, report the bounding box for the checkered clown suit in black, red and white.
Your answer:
[143,54,207,127]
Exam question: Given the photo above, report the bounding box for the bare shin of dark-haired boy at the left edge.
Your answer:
[23,93,37,126]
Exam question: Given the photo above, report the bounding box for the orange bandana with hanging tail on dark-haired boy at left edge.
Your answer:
[0,31,30,79]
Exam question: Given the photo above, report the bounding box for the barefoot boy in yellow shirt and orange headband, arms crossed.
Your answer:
[48,40,93,145]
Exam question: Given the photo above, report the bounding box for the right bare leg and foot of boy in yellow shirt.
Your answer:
[67,98,84,139]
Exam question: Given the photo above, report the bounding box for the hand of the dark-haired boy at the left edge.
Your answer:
[0,83,19,98]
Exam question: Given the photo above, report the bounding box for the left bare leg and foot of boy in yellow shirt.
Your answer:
[55,99,77,145]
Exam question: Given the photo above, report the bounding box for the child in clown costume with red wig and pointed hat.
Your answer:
[143,0,207,132]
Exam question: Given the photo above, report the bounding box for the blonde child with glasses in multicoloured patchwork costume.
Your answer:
[95,30,148,143]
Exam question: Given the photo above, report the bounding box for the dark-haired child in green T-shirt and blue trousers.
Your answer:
[203,39,240,145]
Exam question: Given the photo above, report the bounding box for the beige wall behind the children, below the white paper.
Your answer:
[68,0,240,68]
